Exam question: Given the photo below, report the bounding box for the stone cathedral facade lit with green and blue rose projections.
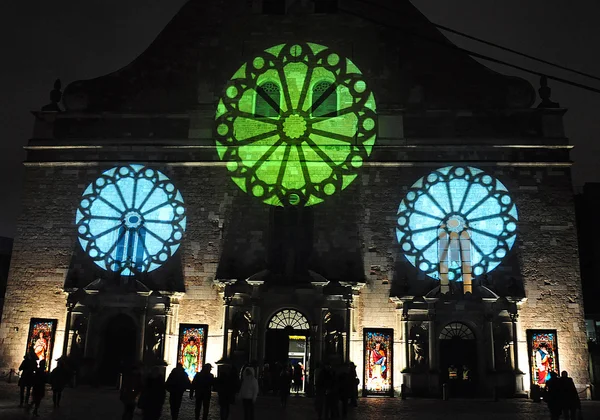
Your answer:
[0,0,589,395]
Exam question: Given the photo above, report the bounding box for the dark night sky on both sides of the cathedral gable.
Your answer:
[0,0,600,237]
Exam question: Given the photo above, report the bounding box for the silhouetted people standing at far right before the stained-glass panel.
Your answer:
[544,371,581,420]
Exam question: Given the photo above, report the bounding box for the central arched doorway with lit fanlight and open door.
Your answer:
[265,309,310,392]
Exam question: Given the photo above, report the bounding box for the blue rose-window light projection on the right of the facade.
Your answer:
[396,166,518,281]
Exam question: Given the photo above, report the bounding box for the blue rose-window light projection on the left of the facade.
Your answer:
[75,165,186,276]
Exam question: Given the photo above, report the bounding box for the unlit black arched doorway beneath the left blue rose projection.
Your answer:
[98,314,137,385]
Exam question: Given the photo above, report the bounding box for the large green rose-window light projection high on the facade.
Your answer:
[216,43,377,206]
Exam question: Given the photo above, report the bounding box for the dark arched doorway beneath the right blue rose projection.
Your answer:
[439,322,477,397]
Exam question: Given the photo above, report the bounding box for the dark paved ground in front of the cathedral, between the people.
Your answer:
[0,382,600,420]
